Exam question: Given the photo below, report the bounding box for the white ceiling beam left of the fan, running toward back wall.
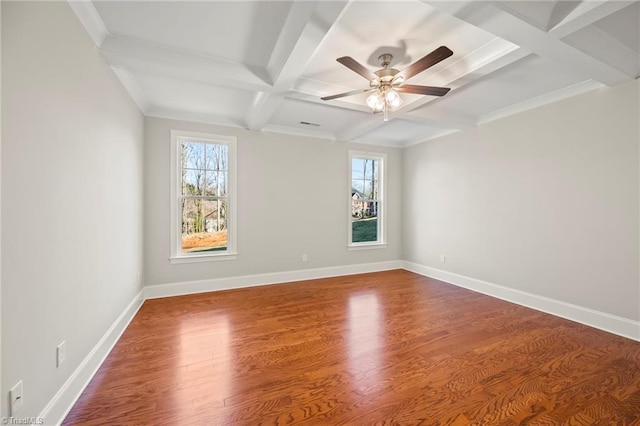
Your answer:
[247,0,349,130]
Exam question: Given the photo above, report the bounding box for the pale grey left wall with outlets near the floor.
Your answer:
[0,2,144,417]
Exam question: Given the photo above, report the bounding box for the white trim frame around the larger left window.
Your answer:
[169,130,238,264]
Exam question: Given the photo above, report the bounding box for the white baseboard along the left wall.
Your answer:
[38,290,144,425]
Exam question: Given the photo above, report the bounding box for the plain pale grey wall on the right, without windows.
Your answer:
[403,81,640,321]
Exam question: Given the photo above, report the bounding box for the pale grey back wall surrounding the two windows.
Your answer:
[144,117,401,285]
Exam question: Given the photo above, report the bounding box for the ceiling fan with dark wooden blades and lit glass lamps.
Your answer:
[321,46,453,121]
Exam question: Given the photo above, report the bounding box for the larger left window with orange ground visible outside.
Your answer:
[171,130,236,263]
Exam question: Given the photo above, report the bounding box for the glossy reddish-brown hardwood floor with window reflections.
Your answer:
[64,270,640,426]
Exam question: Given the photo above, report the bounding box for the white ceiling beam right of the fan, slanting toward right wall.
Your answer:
[423,0,632,86]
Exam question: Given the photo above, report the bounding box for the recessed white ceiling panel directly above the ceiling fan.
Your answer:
[302,1,495,84]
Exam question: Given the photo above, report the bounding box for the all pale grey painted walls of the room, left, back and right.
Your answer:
[0,2,640,416]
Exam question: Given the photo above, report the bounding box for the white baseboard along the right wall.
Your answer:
[403,262,640,341]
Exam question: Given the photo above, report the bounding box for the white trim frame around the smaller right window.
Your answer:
[347,150,387,250]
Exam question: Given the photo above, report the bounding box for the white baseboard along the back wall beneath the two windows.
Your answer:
[144,260,403,299]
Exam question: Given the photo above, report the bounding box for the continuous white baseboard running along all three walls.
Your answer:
[39,260,640,425]
